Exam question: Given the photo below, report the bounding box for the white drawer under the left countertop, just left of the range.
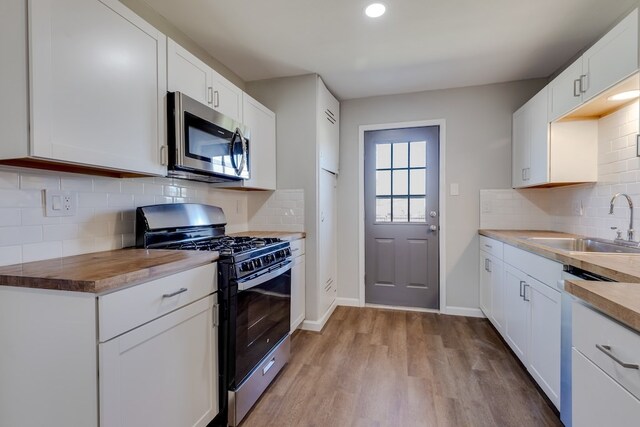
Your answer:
[98,263,218,342]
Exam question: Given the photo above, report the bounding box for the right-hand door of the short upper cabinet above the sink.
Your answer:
[582,9,638,101]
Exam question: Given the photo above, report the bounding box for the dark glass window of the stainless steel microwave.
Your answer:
[184,112,233,167]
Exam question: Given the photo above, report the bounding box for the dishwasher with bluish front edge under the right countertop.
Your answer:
[558,265,614,427]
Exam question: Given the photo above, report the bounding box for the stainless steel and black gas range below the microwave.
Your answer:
[136,203,292,426]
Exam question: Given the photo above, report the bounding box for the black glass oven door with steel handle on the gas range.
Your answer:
[235,261,292,388]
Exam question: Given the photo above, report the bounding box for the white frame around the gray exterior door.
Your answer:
[358,119,447,313]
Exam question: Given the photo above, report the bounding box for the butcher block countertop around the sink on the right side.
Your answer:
[479,230,640,332]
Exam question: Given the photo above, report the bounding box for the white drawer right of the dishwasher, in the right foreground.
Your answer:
[572,302,640,398]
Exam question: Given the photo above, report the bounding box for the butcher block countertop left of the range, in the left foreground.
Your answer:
[0,249,218,294]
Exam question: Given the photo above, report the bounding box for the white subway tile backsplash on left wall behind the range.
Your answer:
[0,166,250,265]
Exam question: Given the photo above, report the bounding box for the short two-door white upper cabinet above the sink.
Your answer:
[549,9,638,121]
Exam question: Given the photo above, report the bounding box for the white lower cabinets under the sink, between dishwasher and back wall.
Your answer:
[480,236,562,408]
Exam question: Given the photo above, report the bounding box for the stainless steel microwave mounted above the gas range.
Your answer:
[167,92,251,182]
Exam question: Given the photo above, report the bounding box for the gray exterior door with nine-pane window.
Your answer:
[364,126,440,309]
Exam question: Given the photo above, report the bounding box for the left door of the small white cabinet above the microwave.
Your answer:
[167,39,213,106]
